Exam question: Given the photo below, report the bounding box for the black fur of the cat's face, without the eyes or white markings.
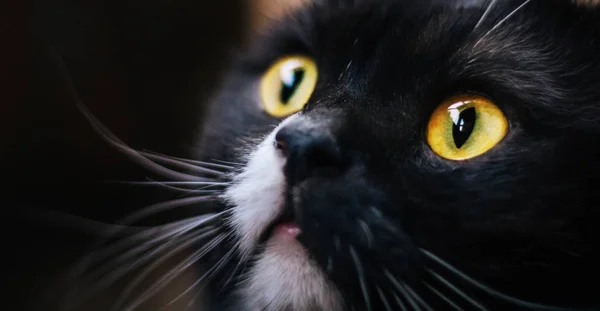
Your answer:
[198,0,600,311]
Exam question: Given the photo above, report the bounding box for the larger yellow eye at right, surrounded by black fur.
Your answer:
[427,95,508,160]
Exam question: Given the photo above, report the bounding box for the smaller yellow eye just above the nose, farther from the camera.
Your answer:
[260,56,317,118]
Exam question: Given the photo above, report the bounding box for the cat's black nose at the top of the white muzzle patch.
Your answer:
[275,123,342,184]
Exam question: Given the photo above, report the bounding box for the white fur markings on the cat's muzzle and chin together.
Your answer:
[224,115,341,311]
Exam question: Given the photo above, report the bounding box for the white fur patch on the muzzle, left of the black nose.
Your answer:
[223,115,295,257]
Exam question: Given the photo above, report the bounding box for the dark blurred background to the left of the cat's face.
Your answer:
[0,0,304,311]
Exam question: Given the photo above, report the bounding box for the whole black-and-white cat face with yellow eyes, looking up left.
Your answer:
[198,0,600,311]
